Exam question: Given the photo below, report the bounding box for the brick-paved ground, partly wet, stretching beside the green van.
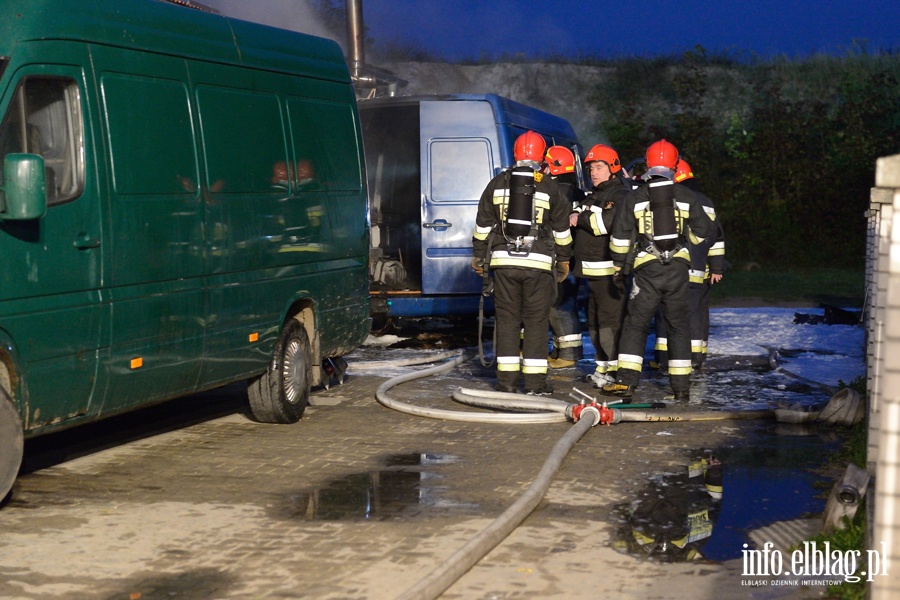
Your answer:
[0,354,828,600]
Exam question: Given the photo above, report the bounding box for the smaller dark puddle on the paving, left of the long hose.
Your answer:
[277,453,475,521]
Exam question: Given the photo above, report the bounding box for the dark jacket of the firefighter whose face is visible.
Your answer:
[575,177,629,279]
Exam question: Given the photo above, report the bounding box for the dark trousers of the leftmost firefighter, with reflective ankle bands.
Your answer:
[493,267,556,392]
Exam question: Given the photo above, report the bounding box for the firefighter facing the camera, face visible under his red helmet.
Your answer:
[569,144,631,387]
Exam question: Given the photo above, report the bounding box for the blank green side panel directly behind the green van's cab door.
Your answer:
[102,74,198,195]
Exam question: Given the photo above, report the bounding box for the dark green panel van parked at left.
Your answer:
[0,0,369,499]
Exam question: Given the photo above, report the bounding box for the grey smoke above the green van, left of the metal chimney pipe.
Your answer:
[199,0,347,48]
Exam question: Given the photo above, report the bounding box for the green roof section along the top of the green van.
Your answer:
[0,0,350,83]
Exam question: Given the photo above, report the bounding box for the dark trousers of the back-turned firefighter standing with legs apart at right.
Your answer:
[616,261,691,392]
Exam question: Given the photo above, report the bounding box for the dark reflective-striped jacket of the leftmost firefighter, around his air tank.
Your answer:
[472,170,572,272]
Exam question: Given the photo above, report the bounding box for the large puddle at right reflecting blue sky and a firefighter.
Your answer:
[613,424,840,562]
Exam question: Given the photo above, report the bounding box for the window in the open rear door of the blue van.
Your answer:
[429,139,493,202]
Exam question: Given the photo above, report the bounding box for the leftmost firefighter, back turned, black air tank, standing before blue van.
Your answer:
[472,131,572,396]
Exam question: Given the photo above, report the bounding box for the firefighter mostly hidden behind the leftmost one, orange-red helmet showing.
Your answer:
[544,146,584,369]
